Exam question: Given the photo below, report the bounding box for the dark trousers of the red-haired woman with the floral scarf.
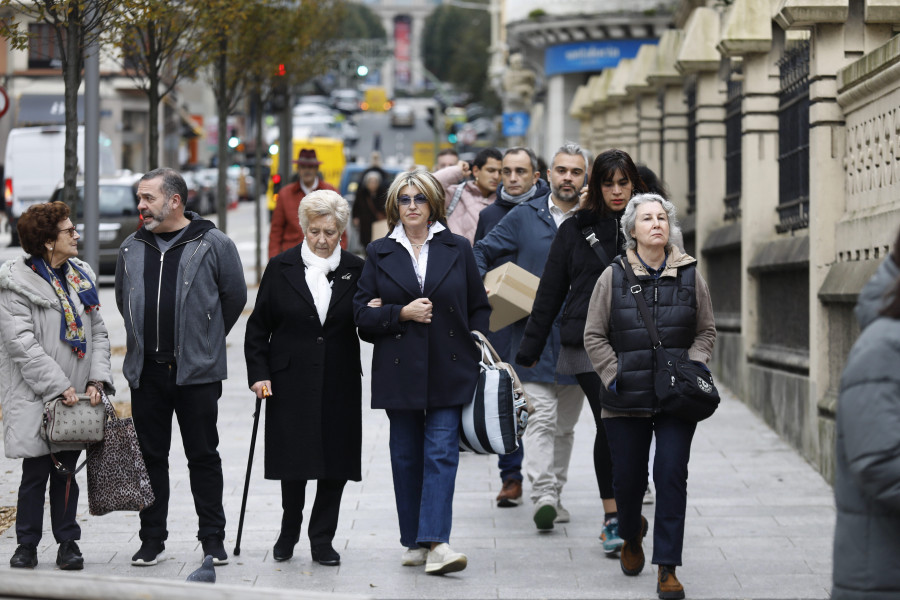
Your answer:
[16,450,81,546]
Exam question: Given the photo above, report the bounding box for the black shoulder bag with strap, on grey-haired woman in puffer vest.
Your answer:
[619,257,719,423]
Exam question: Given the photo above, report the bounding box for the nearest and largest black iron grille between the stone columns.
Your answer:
[775,41,809,233]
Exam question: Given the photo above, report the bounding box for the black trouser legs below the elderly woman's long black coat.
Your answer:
[281,479,347,547]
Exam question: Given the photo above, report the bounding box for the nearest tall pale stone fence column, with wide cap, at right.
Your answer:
[775,0,900,480]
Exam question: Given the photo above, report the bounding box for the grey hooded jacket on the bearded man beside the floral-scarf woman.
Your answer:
[116,212,247,389]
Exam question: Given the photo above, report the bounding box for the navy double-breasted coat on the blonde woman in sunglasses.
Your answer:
[353,229,491,410]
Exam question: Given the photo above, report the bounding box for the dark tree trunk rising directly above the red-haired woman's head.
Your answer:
[60,17,82,209]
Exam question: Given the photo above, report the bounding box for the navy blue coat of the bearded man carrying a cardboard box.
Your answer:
[474,196,576,384]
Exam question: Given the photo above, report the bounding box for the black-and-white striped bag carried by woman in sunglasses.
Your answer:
[459,331,534,454]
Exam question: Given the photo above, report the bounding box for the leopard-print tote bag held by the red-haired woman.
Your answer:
[87,397,155,515]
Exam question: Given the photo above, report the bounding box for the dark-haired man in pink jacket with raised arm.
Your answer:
[434,148,503,244]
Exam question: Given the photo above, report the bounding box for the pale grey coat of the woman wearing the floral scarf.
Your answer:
[0,256,115,458]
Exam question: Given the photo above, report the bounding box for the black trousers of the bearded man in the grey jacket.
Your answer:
[131,360,225,540]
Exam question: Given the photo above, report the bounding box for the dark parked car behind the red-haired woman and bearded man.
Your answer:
[50,173,142,275]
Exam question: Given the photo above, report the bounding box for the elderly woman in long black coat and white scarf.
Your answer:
[244,190,363,566]
